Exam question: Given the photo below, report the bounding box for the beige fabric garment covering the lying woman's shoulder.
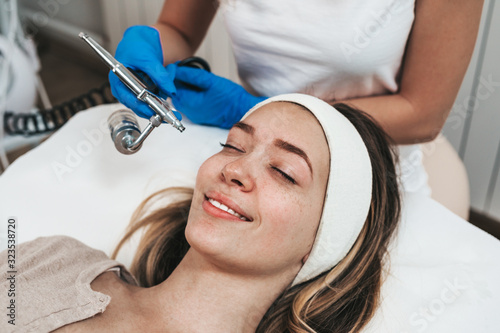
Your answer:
[0,236,136,332]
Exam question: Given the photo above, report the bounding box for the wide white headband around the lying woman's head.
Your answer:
[242,94,372,285]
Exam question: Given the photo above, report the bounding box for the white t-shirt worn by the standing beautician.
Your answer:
[221,0,429,194]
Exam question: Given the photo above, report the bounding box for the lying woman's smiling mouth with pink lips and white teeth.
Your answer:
[202,191,253,222]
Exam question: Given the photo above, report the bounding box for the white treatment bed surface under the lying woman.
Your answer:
[0,104,500,333]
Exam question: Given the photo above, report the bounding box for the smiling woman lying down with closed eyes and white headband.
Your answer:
[1,94,400,333]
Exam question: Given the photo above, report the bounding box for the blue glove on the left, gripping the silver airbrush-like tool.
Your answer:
[109,25,180,120]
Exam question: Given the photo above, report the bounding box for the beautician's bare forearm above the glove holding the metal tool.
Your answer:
[153,0,218,65]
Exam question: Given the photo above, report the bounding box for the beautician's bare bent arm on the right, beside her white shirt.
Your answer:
[340,0,483,144]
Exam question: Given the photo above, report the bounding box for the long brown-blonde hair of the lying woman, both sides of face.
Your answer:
[112,104,400,333]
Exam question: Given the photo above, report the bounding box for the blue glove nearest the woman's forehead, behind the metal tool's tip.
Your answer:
[172,66,266,128]
